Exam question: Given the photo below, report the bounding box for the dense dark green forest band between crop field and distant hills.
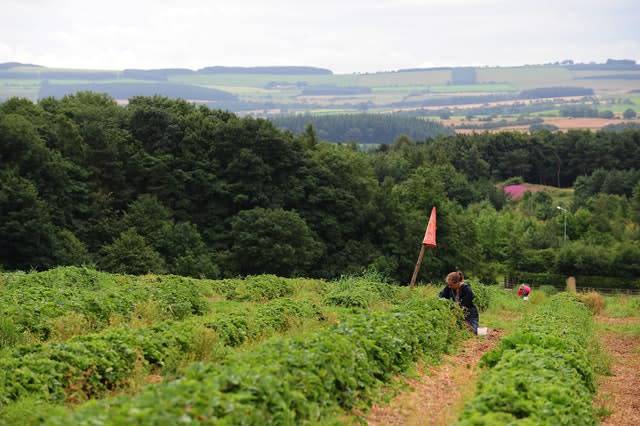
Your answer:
[0,92,640,285]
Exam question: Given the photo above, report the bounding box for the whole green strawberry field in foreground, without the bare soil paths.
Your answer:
[0,267,636,425]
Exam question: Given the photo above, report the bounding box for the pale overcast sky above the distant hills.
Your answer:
[0,0,640,74]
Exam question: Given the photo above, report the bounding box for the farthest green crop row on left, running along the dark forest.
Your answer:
[0,267,390,348]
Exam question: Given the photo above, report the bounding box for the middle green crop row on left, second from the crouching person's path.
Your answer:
[0,299,323,406]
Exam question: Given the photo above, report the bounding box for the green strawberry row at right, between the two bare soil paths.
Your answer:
[458,293,596,425]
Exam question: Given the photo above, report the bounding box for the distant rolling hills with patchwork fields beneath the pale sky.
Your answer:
[0,59,640,134]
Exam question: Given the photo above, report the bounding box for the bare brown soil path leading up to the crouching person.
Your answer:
[365,330,503,426]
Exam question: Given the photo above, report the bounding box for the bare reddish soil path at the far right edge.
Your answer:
[594,317,640,426]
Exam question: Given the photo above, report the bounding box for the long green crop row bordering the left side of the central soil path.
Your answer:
[46,298,462,425]
